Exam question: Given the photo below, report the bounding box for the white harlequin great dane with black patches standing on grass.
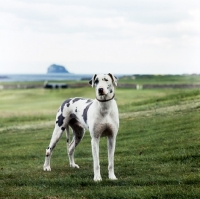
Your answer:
[43,73,119,181]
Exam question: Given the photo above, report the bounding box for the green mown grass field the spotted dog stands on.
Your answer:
[0,84,200,199]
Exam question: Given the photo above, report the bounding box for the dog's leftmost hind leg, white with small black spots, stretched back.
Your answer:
[43,124,65,171]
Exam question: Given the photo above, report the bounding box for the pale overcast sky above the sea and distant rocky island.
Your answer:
[0,0,200,74]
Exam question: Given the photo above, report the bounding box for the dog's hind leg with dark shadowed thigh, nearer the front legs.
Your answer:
[68,119,85,168]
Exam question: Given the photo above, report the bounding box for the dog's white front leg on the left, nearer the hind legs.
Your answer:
[91,137,102,181]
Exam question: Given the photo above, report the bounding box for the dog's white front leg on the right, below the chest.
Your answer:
[108,136,117,180]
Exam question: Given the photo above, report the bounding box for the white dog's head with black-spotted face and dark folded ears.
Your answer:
[89,73,117,100]
